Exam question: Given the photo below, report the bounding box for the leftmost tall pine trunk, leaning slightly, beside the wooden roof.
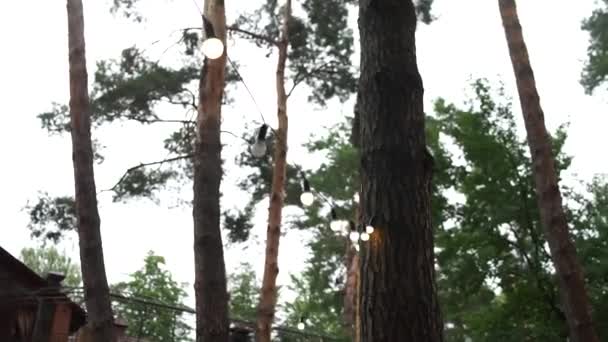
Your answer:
[67,0,114,342]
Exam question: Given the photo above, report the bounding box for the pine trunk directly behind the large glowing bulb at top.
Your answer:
[193,0,229,342]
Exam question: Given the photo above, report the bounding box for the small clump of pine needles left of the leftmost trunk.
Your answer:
[26,193,77,243]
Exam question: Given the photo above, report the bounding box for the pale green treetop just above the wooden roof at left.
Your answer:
[20,246,82,287]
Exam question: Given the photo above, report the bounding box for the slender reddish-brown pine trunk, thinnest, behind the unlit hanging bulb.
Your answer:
[256,0,291,342]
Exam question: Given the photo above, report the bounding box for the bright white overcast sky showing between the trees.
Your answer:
[0,0,608,324]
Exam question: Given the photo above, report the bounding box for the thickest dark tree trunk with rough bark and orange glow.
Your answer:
[358,0,443,342]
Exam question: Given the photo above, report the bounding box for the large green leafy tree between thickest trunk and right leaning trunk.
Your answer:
[435,81,570,341]
